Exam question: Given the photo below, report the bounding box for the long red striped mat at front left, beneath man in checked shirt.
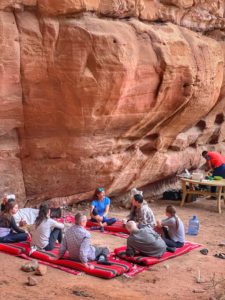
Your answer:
[0,242,132,279]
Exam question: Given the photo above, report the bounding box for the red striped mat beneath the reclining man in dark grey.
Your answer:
[114,242,201,266]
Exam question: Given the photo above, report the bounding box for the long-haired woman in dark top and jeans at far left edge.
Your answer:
[0,201,28,243]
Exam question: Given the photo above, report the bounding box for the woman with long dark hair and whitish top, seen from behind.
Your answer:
[30,204,64,254]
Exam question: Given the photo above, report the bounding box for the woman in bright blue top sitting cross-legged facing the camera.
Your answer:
[91,188,116,232]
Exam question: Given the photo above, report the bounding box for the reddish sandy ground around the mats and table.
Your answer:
[0,198,225,300]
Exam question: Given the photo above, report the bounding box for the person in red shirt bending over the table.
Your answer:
[202,151,225,193]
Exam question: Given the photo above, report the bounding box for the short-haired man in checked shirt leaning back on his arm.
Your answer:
[59,213,109,268]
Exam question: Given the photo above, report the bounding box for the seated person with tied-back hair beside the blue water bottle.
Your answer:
[157,205,185,248]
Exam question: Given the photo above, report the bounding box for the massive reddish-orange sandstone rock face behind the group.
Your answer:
[0,0,225,204]
